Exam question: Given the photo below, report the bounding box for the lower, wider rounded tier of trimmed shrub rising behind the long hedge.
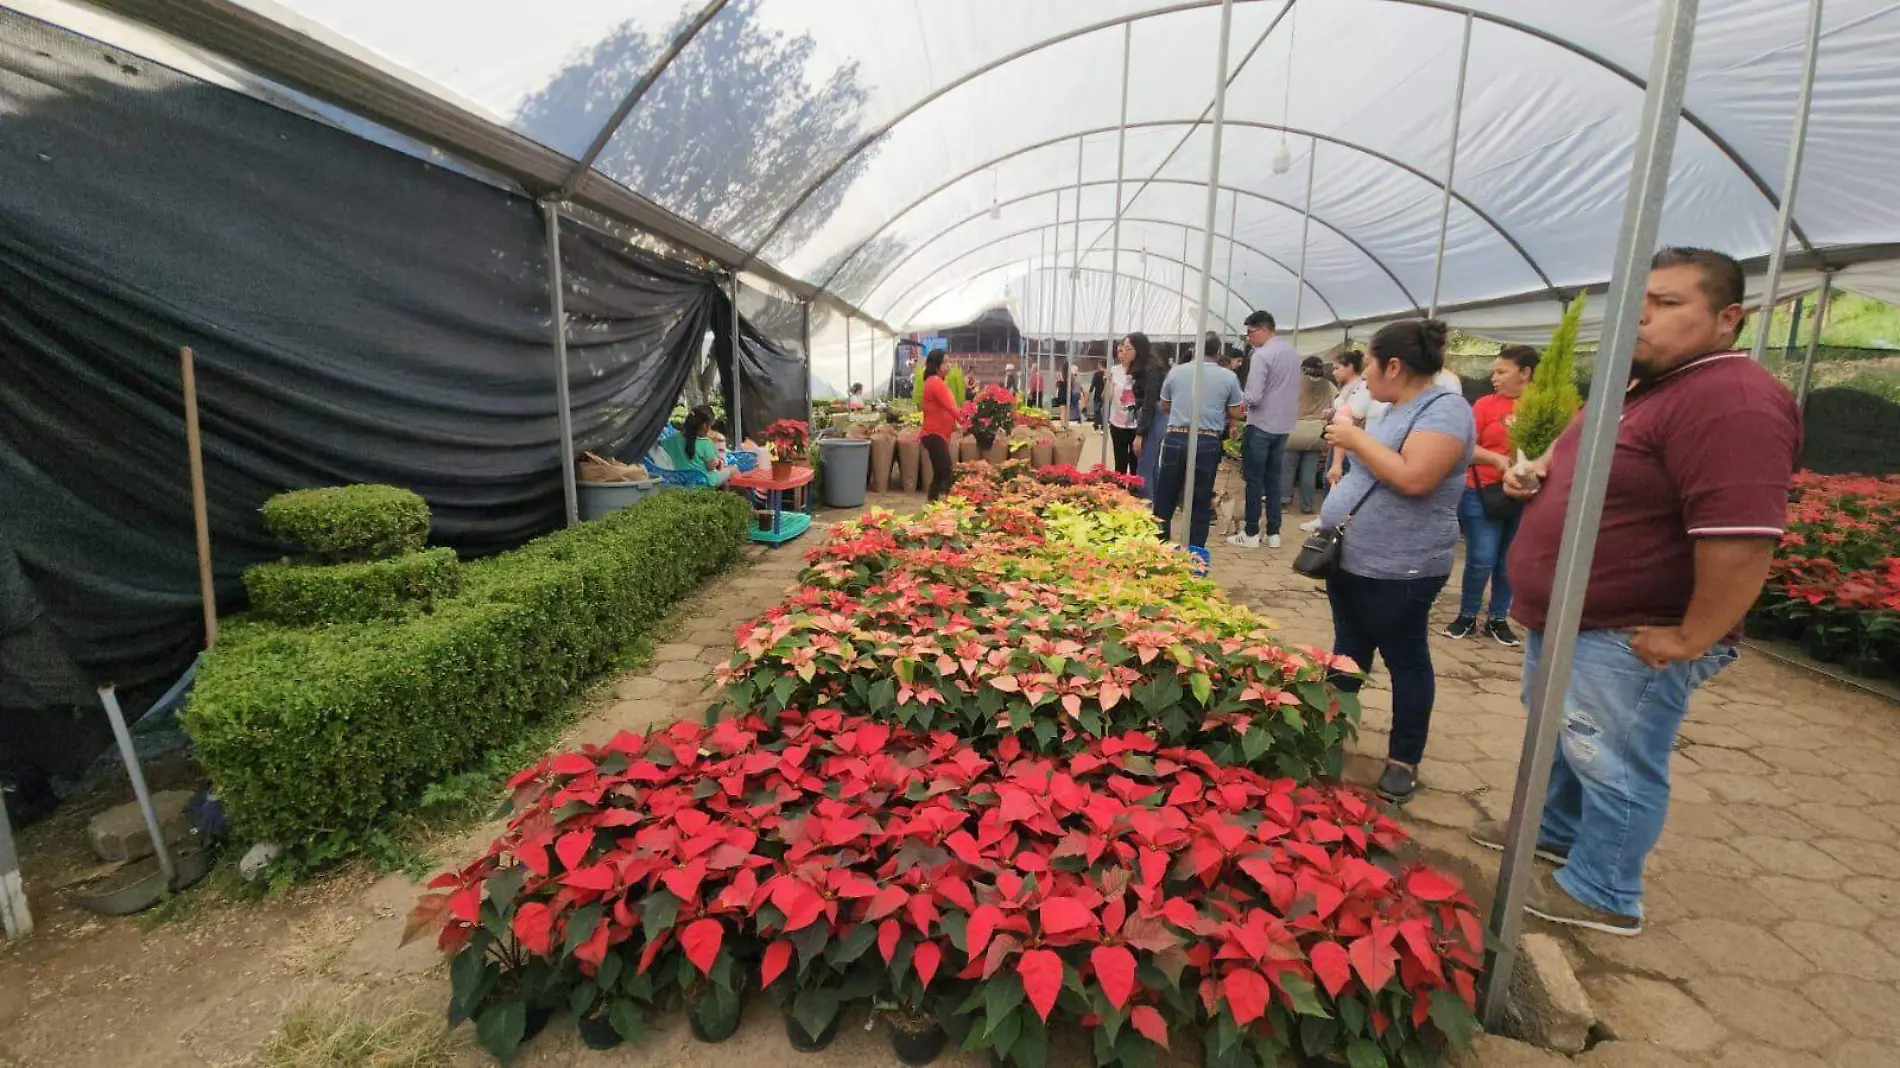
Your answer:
[243,549,462,627]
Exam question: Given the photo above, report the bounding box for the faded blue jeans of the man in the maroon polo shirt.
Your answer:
[1524,631,1737,916]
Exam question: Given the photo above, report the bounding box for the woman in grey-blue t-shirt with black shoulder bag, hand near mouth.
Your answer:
[1321,319,1476,802]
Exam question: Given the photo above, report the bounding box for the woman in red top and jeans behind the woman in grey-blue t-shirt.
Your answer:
[1444,344,1537,646]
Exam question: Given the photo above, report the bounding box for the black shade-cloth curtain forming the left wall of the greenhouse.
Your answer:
[0,10,806,768]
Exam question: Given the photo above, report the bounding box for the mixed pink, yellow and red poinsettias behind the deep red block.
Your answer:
[716,467,1359,779]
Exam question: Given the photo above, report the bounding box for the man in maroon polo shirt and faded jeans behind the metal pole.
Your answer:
[1473,249,1801,935]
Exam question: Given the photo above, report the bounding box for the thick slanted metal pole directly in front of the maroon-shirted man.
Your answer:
[1484,0,1697,1030]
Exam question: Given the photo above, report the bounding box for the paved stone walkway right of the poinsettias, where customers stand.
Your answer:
[1214,545,1900,1068]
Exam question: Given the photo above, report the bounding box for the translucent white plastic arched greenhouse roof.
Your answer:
[33,0,1900,349]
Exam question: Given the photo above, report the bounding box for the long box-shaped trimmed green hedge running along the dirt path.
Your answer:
[184,490,752,844]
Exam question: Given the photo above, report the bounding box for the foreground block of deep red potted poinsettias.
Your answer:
[412,711,1482,1068]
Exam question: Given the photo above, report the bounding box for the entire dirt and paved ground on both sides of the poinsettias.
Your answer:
[0,473,1900,1068]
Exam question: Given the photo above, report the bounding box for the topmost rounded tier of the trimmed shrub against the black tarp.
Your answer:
[262,485,429,561]
